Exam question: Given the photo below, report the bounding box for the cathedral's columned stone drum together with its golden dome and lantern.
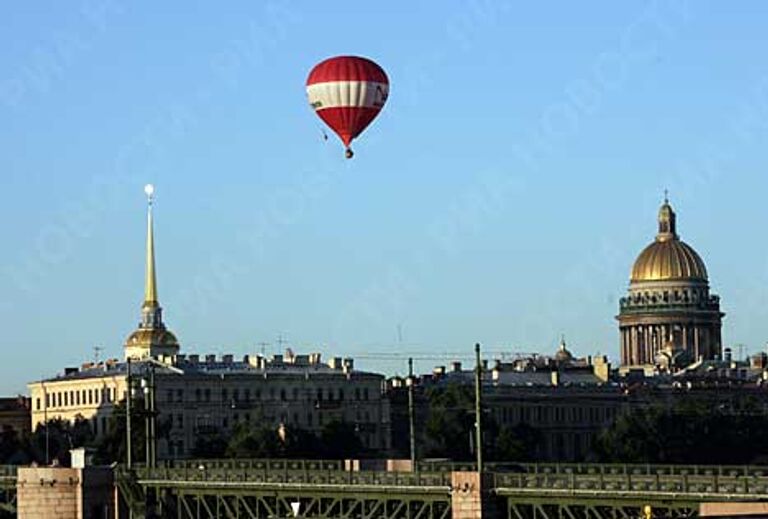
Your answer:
[617,200,725,368]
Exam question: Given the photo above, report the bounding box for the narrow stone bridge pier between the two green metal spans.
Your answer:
[451,472,500,519]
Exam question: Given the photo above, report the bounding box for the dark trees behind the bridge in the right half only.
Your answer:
[418,385,768,465]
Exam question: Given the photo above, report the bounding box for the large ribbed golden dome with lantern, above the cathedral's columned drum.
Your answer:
[630,200,707,283]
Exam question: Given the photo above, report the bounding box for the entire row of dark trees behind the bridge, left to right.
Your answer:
[0,385,768,465]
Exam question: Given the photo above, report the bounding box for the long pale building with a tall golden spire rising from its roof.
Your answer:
[29,191,390,458]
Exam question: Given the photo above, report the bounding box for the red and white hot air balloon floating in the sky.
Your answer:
[307,56,389,159]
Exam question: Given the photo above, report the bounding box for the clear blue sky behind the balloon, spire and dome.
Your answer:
[0,0,768,394]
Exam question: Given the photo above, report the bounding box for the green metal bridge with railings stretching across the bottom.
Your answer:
[0,460,768,519]
